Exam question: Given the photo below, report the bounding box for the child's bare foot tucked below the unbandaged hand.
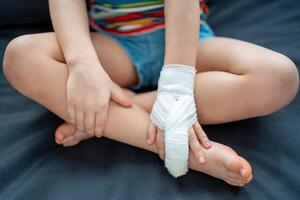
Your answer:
[55,122,95,147]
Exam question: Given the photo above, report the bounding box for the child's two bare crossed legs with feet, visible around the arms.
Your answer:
[4,33,298,186]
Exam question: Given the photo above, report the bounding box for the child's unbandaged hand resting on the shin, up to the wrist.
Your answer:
[67,58,132,137]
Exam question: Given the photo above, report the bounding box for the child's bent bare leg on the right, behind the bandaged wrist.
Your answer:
[134,38,299,124]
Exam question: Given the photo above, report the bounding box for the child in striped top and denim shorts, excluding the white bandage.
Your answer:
[4,0,298,186]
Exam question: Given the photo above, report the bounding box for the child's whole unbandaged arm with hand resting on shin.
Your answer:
[49,0,131,136]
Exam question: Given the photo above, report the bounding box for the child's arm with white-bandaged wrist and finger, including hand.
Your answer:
[148,0,210,177]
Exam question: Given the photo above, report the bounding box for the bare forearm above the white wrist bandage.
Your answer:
[164,0,200,66]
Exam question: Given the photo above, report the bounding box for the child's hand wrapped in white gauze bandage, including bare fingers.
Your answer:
[148,64,210,177]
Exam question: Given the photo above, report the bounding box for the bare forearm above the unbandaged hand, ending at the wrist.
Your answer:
[49,0,97,63]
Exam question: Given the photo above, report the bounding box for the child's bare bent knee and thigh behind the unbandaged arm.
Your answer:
[3,33,137,121]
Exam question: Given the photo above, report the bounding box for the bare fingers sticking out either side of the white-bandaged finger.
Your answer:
[147,121,211,163]
